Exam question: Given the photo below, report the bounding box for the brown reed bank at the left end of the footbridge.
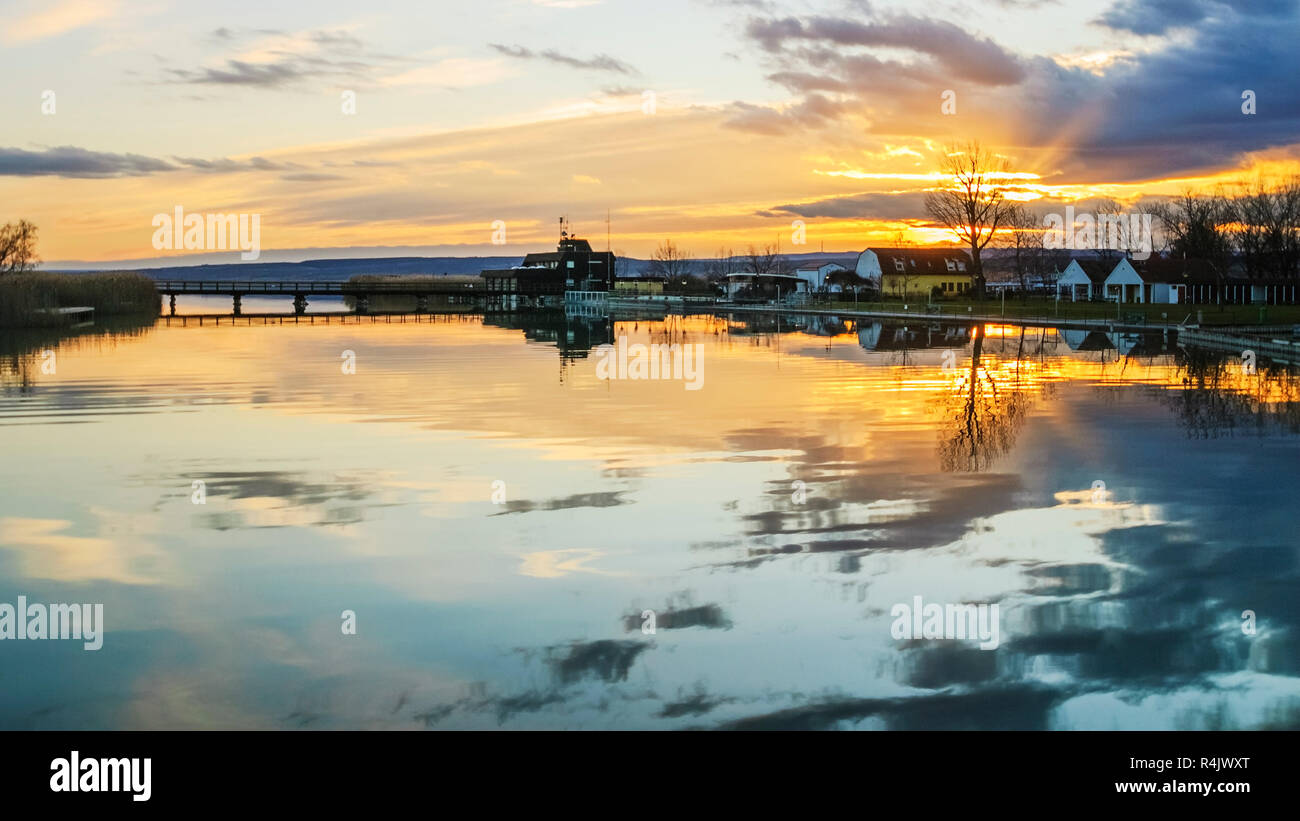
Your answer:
[0,272,163,327]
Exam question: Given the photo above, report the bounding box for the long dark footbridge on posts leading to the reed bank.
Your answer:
[155,277,486,316]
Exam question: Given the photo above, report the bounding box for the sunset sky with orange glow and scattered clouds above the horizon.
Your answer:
[0,0,1300,266]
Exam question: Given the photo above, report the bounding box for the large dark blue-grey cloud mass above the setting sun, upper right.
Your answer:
[728,0,1300,182]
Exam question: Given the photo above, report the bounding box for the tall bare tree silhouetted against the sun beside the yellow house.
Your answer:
[926,140,1013,299]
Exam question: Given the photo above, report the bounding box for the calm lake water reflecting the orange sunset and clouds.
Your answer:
[0,307,1300,729]
